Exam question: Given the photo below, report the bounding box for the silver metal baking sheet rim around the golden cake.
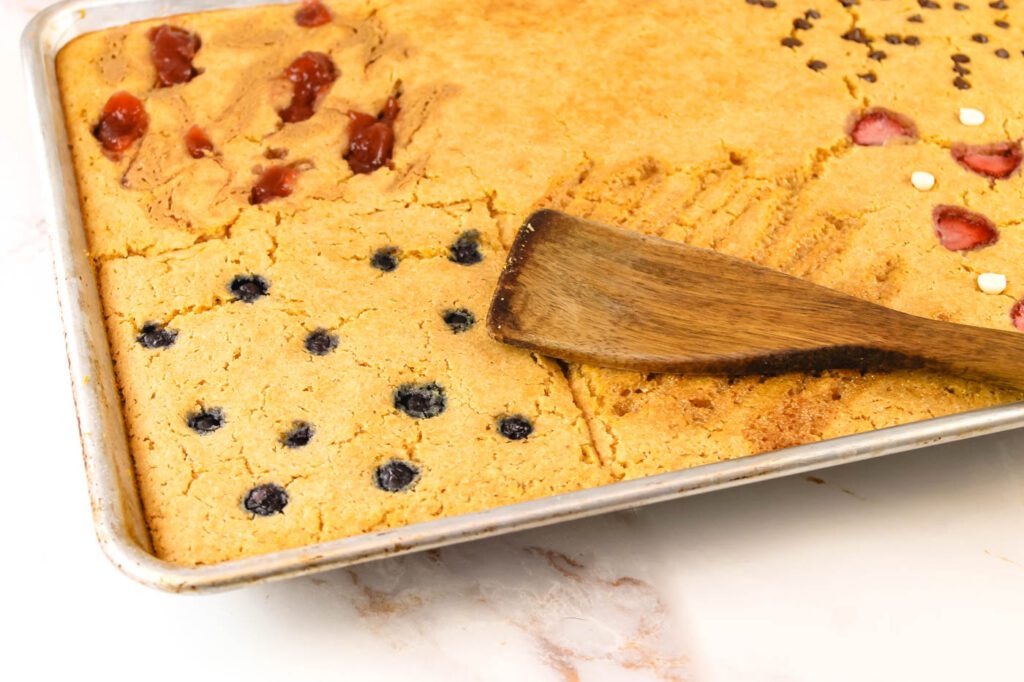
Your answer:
[22,0,1024,592]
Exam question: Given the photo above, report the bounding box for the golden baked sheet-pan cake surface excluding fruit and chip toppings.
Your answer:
[57,0,1024,563]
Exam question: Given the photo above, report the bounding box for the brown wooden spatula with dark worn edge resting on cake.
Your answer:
[487,210,1024,387]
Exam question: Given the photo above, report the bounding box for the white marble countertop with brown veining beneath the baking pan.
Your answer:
[8,0,1024,682]
